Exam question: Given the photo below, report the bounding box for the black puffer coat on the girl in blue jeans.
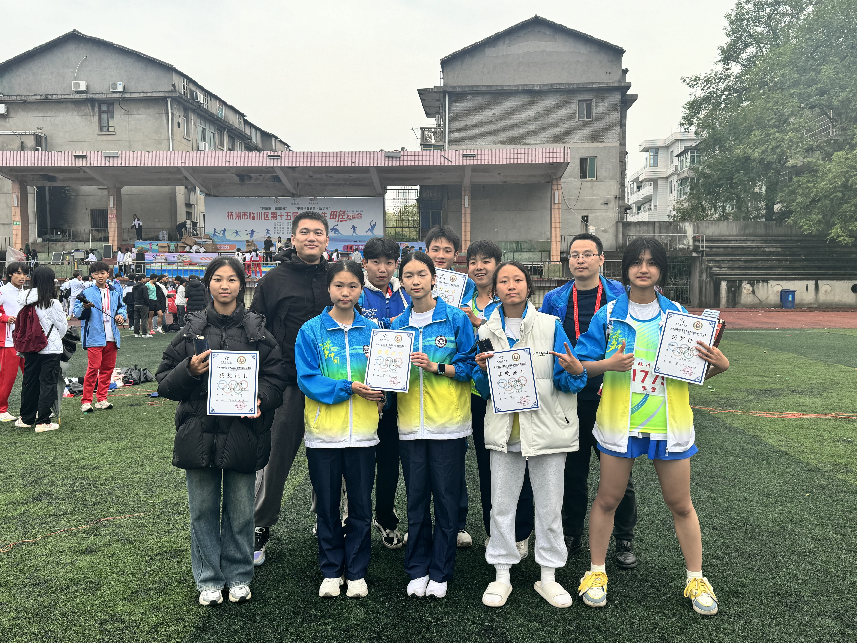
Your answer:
[155,306,286,473]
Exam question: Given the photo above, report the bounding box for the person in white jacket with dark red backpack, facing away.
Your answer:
[16,266,68,433]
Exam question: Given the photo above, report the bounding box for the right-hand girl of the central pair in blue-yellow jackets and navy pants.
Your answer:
[392,252,476,598]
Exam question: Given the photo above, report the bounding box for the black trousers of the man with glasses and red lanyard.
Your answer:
[562,399,637,540]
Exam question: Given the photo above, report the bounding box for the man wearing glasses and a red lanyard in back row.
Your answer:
[539,233,637,569]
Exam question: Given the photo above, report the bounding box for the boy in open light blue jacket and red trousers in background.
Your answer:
[72,261,127,413]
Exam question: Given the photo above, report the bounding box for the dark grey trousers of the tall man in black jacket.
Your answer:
[254,384,306,527]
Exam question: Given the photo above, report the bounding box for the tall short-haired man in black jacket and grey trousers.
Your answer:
[249,212,330,565]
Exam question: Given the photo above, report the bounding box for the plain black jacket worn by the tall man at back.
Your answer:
[250,248,330,384]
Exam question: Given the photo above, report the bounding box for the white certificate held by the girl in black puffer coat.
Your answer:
[208,351,259,416]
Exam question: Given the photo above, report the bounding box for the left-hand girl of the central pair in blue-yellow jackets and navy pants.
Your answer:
[295,261,384,597]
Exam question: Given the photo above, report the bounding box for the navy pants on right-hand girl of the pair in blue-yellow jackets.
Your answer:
[399,438,467,583]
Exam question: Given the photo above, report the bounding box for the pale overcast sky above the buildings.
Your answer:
[0,0,734,171]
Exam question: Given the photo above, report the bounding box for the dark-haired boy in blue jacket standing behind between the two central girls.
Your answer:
[359,237,411,549]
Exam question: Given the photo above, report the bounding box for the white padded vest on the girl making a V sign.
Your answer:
[479,303,586,457]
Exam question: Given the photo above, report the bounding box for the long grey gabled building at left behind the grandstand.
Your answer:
[0,31,289,248]
